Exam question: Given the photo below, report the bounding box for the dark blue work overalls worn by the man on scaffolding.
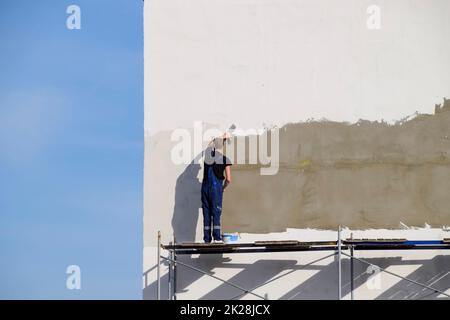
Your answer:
[202,165,223,243]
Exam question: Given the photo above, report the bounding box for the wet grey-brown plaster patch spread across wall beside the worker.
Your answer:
[223,100,450,233]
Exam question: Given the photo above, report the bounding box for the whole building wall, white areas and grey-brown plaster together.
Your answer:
[143,0,450,299]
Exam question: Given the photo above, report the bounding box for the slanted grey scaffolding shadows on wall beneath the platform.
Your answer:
[143,255,450,300]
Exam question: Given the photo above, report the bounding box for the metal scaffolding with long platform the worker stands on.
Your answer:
[156,227,450,300]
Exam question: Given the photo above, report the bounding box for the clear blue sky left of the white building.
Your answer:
[0,0,143,299]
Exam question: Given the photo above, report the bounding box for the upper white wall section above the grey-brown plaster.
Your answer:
[144,0,450,134]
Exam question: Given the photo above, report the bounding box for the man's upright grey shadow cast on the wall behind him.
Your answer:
[172,154,202,243]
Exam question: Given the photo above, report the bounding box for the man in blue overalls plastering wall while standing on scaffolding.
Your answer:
[202,138,231,243]
